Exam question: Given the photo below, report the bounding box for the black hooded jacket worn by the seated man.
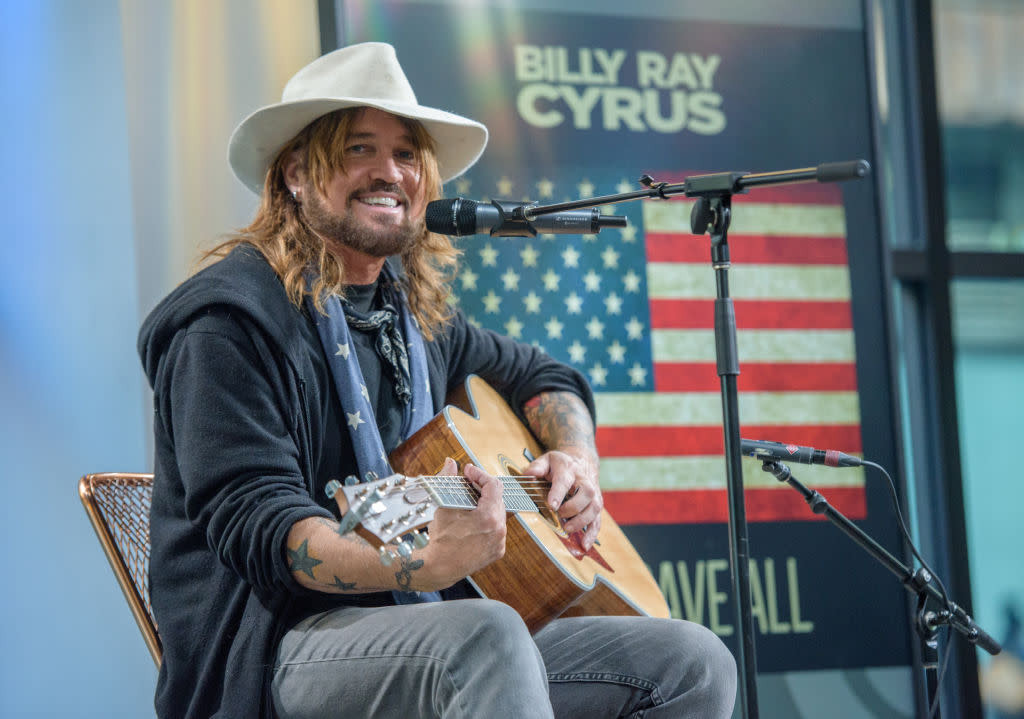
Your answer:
[138,246,593,718]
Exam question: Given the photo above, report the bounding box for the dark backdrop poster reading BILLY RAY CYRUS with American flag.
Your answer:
[337,1,913,708]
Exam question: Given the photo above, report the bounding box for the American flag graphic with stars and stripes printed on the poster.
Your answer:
[455,171,866,524]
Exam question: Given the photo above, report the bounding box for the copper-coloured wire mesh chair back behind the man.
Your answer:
[78,472,163,667]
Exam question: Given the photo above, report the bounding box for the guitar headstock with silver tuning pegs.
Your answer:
[326,474,437,564]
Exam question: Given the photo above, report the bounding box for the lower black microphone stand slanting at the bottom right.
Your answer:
[761,459,1002,717]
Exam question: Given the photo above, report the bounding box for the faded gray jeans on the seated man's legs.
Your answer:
[272,599,736,719]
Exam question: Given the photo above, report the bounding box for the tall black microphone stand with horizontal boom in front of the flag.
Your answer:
[513,160,870,719]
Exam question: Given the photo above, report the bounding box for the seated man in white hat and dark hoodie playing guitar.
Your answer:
[139,43,735,719]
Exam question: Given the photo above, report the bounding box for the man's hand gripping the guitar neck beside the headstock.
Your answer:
[417,459,506,589]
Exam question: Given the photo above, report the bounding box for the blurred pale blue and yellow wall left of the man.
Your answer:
[0,0,319,718]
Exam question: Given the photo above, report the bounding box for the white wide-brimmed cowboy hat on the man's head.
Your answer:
[227,42,487,195]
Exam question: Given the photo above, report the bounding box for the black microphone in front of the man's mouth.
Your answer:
[426,198,627,238]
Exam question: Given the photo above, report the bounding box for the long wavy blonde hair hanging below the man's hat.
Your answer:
[200,108,460,340]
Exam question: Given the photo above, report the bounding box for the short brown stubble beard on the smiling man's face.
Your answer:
[302,187,424,257]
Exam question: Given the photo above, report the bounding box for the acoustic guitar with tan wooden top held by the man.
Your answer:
[328,376,669,632]
